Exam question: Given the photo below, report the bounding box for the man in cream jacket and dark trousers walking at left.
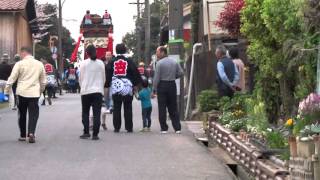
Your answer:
[5,47,46,143]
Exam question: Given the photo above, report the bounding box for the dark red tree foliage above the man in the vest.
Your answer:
[215,0,244,36]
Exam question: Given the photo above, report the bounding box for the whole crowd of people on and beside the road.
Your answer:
[0,44,245,143]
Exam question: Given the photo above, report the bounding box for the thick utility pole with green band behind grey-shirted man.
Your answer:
[169,0,185,120]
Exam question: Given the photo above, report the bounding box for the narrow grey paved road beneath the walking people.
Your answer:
[0,95,232,180]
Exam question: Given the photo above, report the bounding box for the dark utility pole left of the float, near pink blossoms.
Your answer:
[58,0,64,75]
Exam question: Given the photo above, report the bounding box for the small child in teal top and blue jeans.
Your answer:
[137,79,152,132]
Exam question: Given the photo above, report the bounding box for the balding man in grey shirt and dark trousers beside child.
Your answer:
[153,46,183,134]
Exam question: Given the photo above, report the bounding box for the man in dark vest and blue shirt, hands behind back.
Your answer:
[215,46,239,98]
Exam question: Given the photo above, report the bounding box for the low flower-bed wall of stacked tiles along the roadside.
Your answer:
[208,116,289,180]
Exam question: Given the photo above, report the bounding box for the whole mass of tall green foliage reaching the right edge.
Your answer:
[241,0,320,122]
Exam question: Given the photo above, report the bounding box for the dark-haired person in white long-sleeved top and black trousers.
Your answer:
[80,45,106,140]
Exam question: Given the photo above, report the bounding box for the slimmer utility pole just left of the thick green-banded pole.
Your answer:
[144,0,151,64]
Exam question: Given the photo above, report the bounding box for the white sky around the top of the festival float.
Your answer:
[38,0,137,44]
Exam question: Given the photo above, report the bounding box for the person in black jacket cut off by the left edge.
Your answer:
[0,54,12,93]
